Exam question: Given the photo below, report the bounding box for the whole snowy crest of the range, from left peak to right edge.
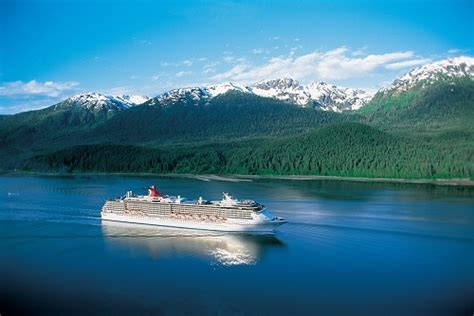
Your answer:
[54,56,474,112]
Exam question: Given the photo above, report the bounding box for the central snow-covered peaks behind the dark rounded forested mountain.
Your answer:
[147,78,372,112]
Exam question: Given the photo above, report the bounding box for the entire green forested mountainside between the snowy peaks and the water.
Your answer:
[0,78,474,179]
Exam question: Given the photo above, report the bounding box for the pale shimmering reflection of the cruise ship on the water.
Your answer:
[102,221,285,266]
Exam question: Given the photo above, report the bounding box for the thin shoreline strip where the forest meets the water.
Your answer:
[0,171,474,187]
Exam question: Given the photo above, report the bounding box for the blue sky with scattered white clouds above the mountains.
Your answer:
[0,0,474,114]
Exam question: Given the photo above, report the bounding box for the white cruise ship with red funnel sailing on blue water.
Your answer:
[101,186,286,233]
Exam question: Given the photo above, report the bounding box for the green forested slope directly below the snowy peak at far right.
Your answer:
[360,77,474,135]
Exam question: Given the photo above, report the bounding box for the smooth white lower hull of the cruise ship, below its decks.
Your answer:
[101,212,285,234]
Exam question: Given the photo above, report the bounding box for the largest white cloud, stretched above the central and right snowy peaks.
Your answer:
[211,47,420,83]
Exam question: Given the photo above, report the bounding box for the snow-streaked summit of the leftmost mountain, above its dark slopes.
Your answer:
[56,92,150,111]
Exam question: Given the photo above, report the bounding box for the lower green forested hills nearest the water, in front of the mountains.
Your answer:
[22,123,474,179]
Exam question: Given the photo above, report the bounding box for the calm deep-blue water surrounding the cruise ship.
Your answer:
[0,176,474,315]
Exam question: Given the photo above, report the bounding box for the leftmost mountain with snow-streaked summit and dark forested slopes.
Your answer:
[0,93,148,162]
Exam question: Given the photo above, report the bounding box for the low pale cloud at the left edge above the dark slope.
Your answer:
[0,80,79,97]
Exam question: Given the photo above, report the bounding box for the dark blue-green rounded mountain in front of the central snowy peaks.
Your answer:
[90,90,348,145]
